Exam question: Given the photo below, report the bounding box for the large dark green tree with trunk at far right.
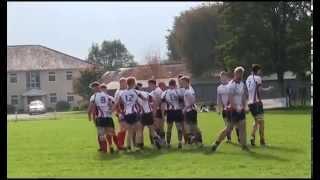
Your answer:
[219,1,312,95]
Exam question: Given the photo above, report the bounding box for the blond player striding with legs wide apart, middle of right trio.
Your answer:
[211,67,249,151]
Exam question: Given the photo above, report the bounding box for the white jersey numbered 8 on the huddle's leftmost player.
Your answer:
[90,92,114,117]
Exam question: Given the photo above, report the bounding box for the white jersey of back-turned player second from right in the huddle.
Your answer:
[161,89,181,110]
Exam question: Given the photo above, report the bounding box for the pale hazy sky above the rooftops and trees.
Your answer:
[7,2,201,64]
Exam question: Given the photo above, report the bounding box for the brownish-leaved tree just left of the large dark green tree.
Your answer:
[167,4,224,76]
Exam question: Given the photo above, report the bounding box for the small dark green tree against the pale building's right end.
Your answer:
[73,67,104,100]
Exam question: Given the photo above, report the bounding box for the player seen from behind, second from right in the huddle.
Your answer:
[161,79,183,149]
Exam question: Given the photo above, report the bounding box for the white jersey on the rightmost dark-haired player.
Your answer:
[246,74,262,104]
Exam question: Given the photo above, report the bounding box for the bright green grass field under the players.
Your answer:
[7,110,311,177]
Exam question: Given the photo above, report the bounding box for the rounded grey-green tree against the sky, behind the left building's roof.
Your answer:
[88,40,137,70]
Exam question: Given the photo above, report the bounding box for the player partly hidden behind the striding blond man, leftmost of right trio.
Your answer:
[217,71,240,143]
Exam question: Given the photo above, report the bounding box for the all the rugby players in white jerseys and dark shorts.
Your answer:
[88,65,266,153]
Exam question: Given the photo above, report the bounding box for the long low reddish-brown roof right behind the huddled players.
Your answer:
[101,63,191,84]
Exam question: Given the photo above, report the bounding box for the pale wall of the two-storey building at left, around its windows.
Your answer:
[7,69,82,111]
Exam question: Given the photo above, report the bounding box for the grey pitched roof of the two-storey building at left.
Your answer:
[7,45,93,71]
